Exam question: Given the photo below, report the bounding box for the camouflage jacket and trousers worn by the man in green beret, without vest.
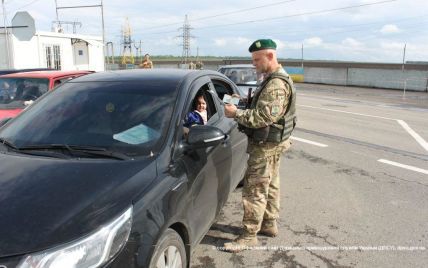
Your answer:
[235,66,291,236]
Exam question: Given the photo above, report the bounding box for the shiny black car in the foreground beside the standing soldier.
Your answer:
[0,69,248,268]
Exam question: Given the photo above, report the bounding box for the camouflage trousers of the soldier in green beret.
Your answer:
[242,153,281,234]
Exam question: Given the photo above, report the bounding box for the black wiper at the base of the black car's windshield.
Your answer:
[19,144,132,160]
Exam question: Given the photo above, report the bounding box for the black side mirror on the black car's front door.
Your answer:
[187,125,227,149]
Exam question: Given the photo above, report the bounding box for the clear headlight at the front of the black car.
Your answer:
[18,207,132,268]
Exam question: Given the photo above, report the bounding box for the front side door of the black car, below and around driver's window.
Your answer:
[180,77,226,242]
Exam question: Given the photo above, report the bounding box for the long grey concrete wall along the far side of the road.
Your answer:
[108,59,428,92]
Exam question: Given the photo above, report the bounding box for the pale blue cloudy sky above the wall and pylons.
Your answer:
[0,0,428,63]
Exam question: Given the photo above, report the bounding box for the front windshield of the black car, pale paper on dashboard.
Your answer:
[0,82,176,156]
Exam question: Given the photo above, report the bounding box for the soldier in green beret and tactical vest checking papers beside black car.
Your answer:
[224,39,296,252]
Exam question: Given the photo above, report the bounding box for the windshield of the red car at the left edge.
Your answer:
[0,77,49,109]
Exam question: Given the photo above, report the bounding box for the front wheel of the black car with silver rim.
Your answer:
[150,229,187,268]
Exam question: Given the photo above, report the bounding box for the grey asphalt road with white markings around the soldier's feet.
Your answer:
[191,84,428,268]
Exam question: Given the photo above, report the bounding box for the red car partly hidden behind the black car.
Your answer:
[0,71,92,120]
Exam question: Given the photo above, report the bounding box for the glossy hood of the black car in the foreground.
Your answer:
[0,153,156,257]
